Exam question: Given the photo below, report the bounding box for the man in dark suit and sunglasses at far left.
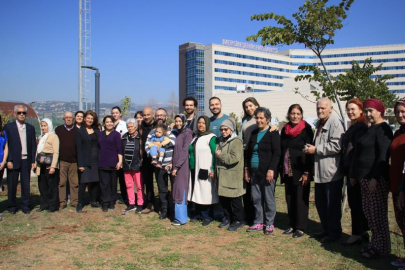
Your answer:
[4,105,37,214]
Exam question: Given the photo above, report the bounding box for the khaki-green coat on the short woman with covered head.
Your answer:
[216,136,246,198]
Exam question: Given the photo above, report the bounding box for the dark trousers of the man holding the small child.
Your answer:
[155,167,174,214]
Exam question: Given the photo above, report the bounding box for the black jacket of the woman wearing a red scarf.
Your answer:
[279,125,314,184]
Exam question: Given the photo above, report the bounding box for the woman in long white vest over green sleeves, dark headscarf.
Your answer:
[188,116,219,226]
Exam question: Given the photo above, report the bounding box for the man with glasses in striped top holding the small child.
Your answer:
[142,108,176,219]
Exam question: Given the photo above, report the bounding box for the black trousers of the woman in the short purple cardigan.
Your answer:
[98,169,117,206]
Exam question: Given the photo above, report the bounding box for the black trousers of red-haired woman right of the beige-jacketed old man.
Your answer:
[347,182,369,235]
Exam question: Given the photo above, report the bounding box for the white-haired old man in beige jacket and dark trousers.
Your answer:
[304,98,344,243]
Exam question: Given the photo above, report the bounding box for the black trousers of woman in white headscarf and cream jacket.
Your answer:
[38,166,59,211]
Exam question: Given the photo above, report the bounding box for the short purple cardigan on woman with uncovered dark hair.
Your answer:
[98,130,122,168]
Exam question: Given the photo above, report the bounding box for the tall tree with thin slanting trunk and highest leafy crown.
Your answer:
[247,0,354,121]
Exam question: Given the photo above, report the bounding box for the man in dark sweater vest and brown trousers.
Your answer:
[55,112,79,209]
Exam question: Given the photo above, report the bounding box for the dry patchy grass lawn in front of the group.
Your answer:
[0,178,404,270]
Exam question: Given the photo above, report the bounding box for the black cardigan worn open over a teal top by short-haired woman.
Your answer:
[245,129,281,178]
